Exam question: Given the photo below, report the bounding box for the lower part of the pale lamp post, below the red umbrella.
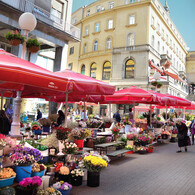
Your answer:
[10,91,22,137]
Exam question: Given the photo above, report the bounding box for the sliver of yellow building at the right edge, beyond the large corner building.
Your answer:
[186,51,195,101]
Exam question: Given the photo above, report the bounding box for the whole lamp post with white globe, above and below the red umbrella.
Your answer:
[10,12,37,137]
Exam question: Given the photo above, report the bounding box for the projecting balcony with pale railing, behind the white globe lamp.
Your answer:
[0,0,80,41]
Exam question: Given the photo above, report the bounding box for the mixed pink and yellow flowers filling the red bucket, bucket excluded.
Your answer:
[70,127,91,140]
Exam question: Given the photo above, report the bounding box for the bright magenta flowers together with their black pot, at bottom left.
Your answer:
[16,176,42,195]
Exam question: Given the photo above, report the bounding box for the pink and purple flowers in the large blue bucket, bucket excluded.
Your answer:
[10,144,42,165]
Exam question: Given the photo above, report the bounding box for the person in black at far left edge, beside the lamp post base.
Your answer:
[0,110,11,135]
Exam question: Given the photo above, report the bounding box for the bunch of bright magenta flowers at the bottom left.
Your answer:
[17,176,42,191]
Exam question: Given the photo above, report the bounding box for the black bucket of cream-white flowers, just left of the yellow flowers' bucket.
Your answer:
[70,169,84,186]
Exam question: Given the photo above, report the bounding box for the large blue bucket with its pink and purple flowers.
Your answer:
[10,144,42,182]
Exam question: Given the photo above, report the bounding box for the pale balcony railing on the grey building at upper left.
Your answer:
[0,0,80,39]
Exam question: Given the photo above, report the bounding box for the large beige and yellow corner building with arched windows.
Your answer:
[67,0,187,114]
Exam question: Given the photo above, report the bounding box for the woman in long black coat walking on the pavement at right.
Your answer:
[176,119,188,153]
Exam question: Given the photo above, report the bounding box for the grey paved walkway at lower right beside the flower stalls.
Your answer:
[71,143,195,195]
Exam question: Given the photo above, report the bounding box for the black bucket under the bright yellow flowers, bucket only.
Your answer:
[87,171,100,187]
